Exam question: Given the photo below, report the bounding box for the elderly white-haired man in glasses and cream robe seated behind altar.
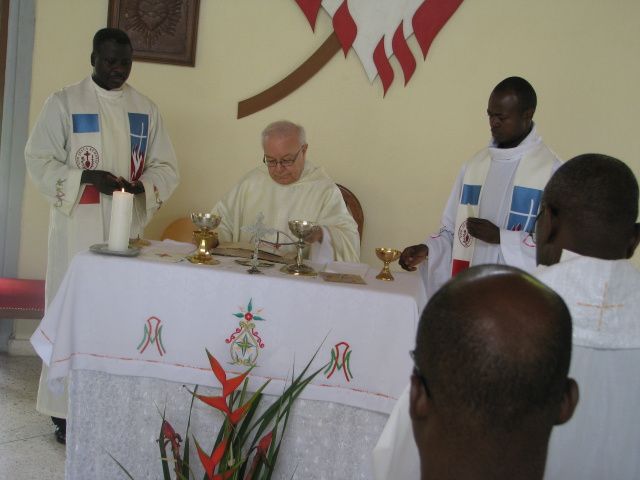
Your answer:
[212,120,360,262]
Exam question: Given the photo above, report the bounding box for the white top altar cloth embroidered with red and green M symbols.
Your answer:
[31,246,425,414]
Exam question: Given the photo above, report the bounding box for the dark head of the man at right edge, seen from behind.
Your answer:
[537,153,640,265]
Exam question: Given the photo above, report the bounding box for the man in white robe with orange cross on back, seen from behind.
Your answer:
[373,154,640,480]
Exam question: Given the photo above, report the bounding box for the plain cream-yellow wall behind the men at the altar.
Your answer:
[20,0,640,277]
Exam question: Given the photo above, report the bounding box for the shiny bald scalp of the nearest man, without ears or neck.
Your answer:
[415,265,571,435]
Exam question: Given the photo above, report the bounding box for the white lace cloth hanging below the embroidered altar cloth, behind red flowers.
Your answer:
[66,370,387,480]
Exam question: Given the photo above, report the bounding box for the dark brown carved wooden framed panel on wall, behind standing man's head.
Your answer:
[107,0,200,67]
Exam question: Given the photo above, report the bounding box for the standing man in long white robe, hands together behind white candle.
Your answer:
[25,29,178,440]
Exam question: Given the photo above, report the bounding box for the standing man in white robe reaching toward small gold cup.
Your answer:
[400,77,560,297]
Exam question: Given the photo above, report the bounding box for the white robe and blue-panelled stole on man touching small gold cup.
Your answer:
[420,125,561,297]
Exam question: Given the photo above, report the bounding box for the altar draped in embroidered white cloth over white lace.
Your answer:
[32,242,425,479]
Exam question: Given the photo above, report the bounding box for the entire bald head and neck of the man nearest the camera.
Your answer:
[410,265,578,478]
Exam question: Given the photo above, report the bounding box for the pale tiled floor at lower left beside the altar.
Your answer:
[0,354,65,480]
